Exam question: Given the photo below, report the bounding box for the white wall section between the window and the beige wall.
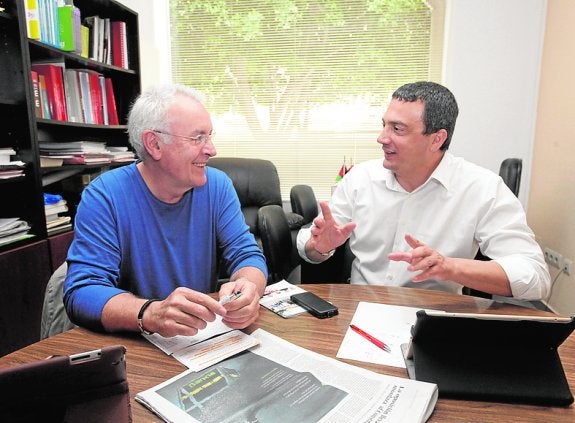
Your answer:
[444,0,547,208]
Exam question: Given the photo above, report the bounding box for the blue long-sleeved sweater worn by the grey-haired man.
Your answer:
[64,163,267,330]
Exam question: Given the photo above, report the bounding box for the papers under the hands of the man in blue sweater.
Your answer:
[142,316,258,371]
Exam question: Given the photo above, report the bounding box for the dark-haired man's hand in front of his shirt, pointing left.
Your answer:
[387,234,450,282]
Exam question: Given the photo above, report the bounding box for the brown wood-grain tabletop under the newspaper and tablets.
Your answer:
[0,284,575,423]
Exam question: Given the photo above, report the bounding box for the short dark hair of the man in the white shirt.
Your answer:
[391,81,459,151]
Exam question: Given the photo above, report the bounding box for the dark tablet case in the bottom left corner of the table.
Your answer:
[0,345,131,423]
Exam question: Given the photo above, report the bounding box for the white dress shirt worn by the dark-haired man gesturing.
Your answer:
[297,153,551,300]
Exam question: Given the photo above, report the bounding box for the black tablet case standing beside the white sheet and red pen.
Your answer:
[406,310,575,406]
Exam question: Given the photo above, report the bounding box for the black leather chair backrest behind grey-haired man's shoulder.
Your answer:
[208,157,282,237]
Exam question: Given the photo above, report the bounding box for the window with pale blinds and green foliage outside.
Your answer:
[170,0,444,200]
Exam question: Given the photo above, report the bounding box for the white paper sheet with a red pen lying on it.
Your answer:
[337,302,440,368]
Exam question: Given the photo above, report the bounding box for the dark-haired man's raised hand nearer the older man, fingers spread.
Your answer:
[306,201,356,261]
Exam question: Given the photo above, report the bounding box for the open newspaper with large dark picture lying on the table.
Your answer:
[136,329,437,423]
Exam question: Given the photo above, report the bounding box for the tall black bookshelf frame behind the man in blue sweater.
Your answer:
[0,0,141,355]
